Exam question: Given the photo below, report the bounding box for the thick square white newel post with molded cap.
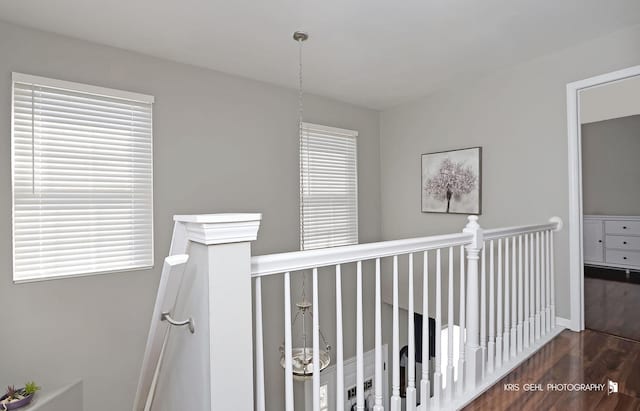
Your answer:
[174,213,262,410]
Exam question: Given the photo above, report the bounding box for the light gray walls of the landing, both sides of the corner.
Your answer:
[0,13,640,411]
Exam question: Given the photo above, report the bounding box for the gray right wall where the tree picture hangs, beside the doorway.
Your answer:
[380,26,640,317]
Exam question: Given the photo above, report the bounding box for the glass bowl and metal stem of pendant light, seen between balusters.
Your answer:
[280,274,331,381]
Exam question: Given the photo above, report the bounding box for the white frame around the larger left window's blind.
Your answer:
[10,72,155,284]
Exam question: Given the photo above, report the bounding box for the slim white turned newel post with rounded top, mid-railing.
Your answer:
[462,215,483,389]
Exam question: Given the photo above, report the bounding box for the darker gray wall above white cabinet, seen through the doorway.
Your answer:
[582,115,640,215]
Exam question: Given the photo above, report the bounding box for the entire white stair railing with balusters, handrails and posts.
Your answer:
[134,214,562,411]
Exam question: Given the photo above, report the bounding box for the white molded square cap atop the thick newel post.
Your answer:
[173,213,262,245]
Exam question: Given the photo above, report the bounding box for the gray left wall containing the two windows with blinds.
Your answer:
[0,23,380,411]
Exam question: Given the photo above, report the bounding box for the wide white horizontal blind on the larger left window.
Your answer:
[12,73,153,282]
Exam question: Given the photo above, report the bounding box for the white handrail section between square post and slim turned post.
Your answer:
[251,233,473,277]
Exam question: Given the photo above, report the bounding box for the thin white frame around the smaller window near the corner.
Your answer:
[298,122,360,251]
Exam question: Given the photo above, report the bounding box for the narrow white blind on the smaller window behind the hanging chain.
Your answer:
[300,123,358,250]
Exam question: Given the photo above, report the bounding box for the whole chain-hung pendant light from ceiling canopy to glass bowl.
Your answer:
[280,31,331,381]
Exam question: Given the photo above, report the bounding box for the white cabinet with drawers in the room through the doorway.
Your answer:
[583,215,640,270]
